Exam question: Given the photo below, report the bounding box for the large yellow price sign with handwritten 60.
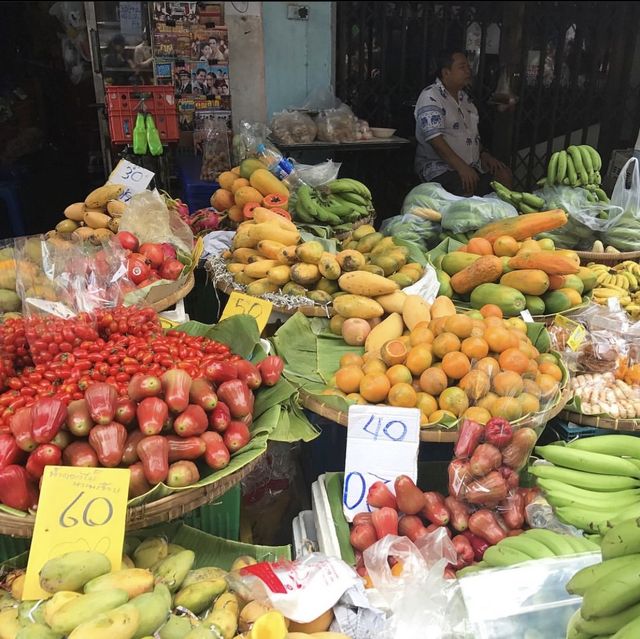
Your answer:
[22,466,131,600]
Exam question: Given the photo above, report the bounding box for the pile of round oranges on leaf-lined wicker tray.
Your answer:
[325,304,563,426]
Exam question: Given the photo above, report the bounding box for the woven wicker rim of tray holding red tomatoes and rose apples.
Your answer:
[0,455,262,537]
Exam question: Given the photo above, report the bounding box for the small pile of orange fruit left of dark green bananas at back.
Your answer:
[211,158,291,223]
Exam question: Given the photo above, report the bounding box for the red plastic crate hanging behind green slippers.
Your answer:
[106,84,180,144]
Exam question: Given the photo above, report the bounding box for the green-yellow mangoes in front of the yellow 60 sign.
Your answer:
[0,537,349,639]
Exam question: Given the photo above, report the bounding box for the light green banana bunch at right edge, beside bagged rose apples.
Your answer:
[529,435,640,536]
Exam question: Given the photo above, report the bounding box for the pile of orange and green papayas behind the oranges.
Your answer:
[436,210,596,316]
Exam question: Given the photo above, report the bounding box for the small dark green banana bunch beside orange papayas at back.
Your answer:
[295,178,373,226]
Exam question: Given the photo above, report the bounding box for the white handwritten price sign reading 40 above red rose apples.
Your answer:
[342,406,420,521]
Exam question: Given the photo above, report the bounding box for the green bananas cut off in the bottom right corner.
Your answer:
[566,516,640,639]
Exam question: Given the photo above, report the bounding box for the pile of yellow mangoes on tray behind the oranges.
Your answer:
[223,218,423,308]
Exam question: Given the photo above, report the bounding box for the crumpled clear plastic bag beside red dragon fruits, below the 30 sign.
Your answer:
[120,191,193,255]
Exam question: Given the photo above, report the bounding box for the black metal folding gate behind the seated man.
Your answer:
[336,2,640,188]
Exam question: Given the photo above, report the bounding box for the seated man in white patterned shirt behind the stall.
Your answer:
[414,49,512,196]
